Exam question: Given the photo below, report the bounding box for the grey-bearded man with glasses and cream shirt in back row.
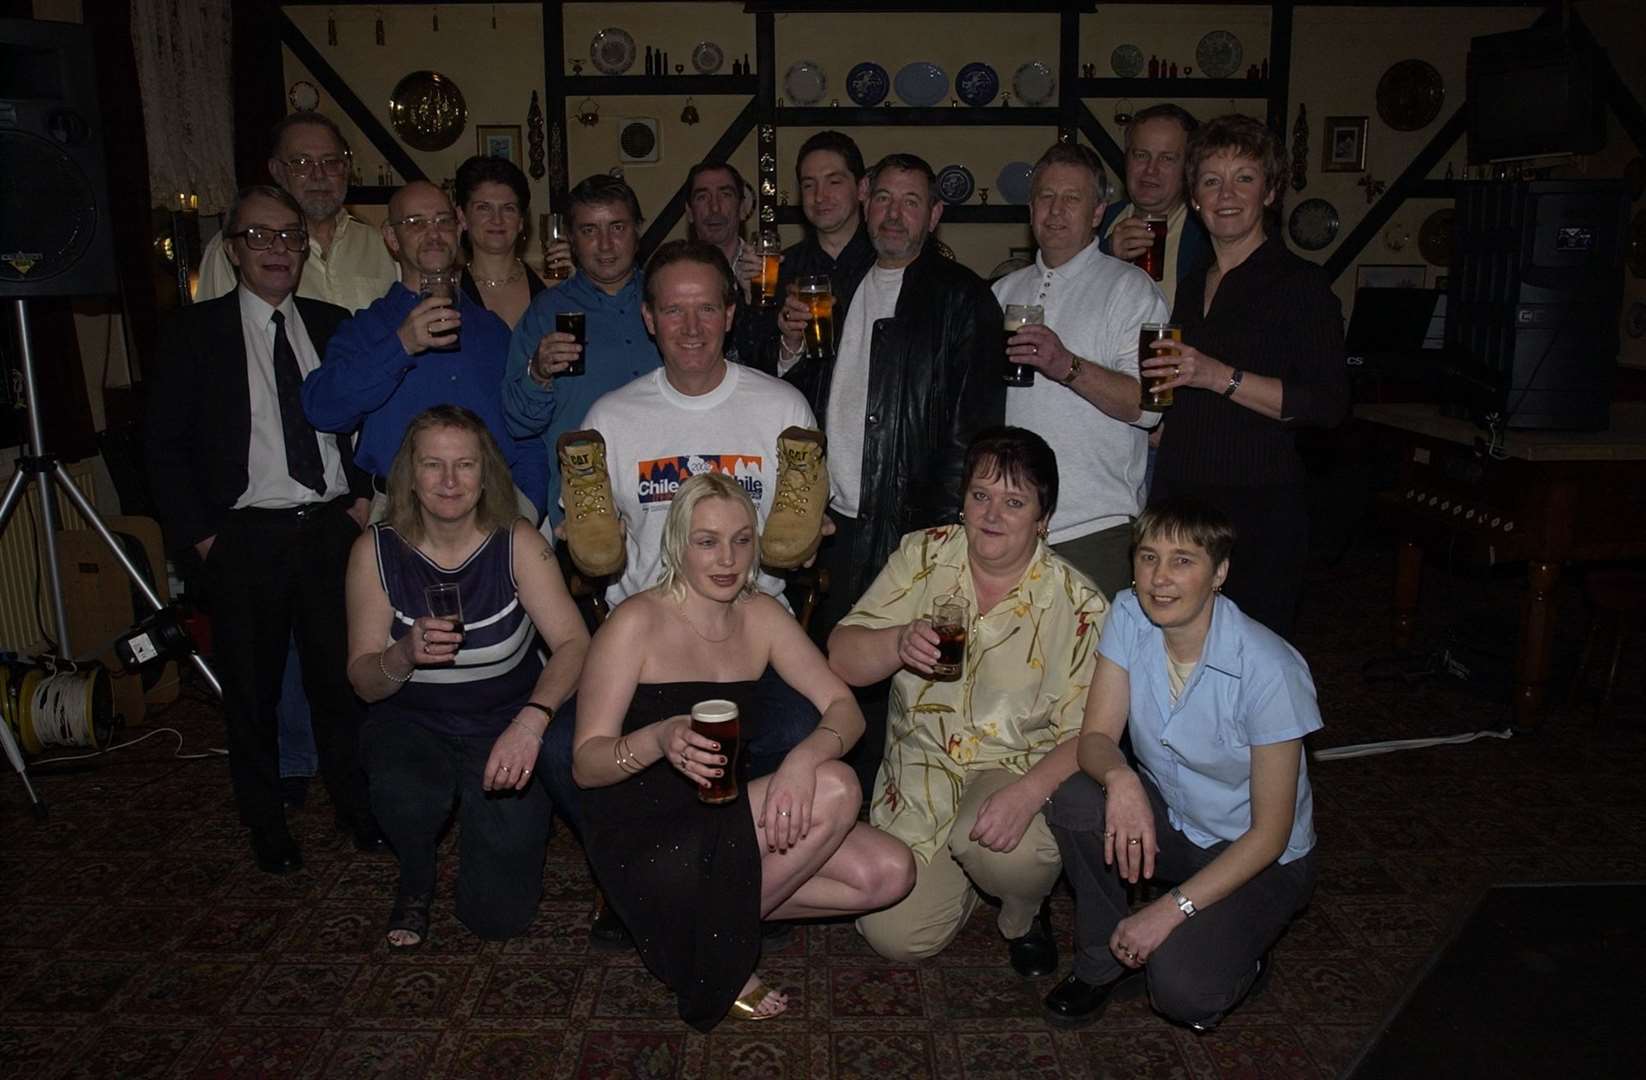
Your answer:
[194,112,400,311]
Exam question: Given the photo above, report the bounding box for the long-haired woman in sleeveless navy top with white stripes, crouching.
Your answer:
[349,405,589,948]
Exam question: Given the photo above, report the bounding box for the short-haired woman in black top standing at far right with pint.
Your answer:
[1142,115,1348,637]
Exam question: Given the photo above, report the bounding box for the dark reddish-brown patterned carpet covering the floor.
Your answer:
[0,542,1646,1080]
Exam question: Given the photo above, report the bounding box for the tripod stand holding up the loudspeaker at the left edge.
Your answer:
[0,300,222,820]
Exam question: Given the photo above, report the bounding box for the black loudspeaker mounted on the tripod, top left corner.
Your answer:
[0,18,116,296]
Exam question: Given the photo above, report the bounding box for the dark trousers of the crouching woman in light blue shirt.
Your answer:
[1045,772,1315,1024]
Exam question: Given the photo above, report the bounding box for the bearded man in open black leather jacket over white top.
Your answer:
[782,153,1006,640]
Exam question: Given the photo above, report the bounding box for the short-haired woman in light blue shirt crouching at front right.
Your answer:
[1045,499,1322,1032]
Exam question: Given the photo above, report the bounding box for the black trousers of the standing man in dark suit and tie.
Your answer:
[204,497,367,830]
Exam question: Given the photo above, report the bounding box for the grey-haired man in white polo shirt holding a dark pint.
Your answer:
[994,143,1167,598]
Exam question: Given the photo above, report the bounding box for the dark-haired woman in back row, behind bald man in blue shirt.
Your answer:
[456,156,546,329]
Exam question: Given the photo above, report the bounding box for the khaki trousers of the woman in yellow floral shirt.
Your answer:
[858,769,1063,960]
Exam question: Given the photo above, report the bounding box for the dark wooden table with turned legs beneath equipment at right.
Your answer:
[1355,402,1646,728]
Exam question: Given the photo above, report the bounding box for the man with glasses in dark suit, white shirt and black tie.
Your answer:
[146,186,382,874]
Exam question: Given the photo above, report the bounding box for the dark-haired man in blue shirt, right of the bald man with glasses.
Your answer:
[502,175,662,525]
